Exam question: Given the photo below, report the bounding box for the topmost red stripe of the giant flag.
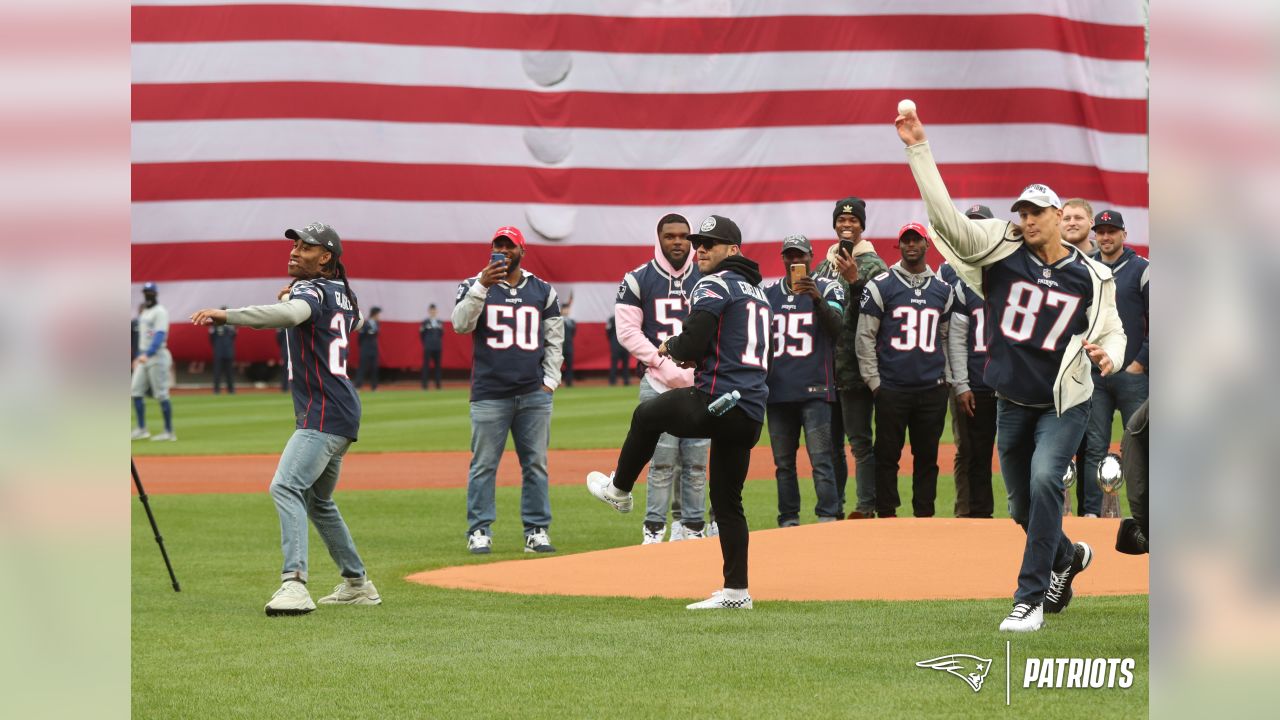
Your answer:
[133,5,1143,60]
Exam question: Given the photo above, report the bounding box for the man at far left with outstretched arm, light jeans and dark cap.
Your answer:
[191,223,383,615]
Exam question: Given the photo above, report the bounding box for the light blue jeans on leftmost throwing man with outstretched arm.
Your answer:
[271,430,365,580]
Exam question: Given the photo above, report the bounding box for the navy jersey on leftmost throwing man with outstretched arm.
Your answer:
[284,278,360,441]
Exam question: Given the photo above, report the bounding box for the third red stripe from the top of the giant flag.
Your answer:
[133,158,1148,208]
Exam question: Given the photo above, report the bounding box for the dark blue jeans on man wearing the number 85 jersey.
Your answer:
[768,400,841,525]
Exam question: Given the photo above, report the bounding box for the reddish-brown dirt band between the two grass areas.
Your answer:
[133,445,972,495]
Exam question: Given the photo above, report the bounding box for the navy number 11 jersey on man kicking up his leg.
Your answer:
[690,270,773,423]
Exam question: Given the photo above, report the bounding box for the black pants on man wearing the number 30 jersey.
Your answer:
[876,386,950,518]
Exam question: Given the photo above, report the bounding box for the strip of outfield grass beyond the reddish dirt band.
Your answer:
[131,384,1120,455]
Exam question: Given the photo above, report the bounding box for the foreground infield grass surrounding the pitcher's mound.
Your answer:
[132,482,1148,719]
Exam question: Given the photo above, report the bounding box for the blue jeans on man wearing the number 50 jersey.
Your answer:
[467,388,552,536]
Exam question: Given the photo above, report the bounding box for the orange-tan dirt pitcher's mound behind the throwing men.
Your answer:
[408,518,1148,600]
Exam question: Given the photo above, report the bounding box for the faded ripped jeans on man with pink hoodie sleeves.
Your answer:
[640,375,712,525]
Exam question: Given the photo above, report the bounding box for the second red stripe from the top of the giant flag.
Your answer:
[133,82,1147,135]
